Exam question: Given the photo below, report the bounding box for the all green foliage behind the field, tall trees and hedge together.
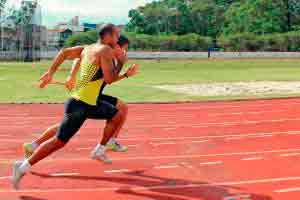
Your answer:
[65,0,300,51]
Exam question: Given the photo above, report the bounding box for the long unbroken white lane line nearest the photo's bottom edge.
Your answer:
[0,176,300,193]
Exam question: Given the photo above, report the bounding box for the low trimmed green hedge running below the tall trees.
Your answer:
[65,31,300,51]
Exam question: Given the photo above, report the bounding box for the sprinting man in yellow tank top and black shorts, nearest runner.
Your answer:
[12,24,138,189]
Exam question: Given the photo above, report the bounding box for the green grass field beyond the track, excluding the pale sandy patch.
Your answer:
[0,60,300,103]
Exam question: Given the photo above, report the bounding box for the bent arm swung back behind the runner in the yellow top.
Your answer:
[39,46,84,88]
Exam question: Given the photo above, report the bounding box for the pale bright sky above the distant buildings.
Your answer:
[7,0,154,27]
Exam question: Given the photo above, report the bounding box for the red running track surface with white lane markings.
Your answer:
[0,99,300,200]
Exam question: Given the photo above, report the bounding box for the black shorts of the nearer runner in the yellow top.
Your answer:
[57,98,118,143]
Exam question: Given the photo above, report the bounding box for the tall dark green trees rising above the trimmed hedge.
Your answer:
[127,0,300,37]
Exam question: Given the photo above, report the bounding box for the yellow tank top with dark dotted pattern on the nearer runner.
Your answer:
[71,47,103,106]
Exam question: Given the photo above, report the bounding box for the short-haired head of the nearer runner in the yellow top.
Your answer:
[99,24,120,47]
